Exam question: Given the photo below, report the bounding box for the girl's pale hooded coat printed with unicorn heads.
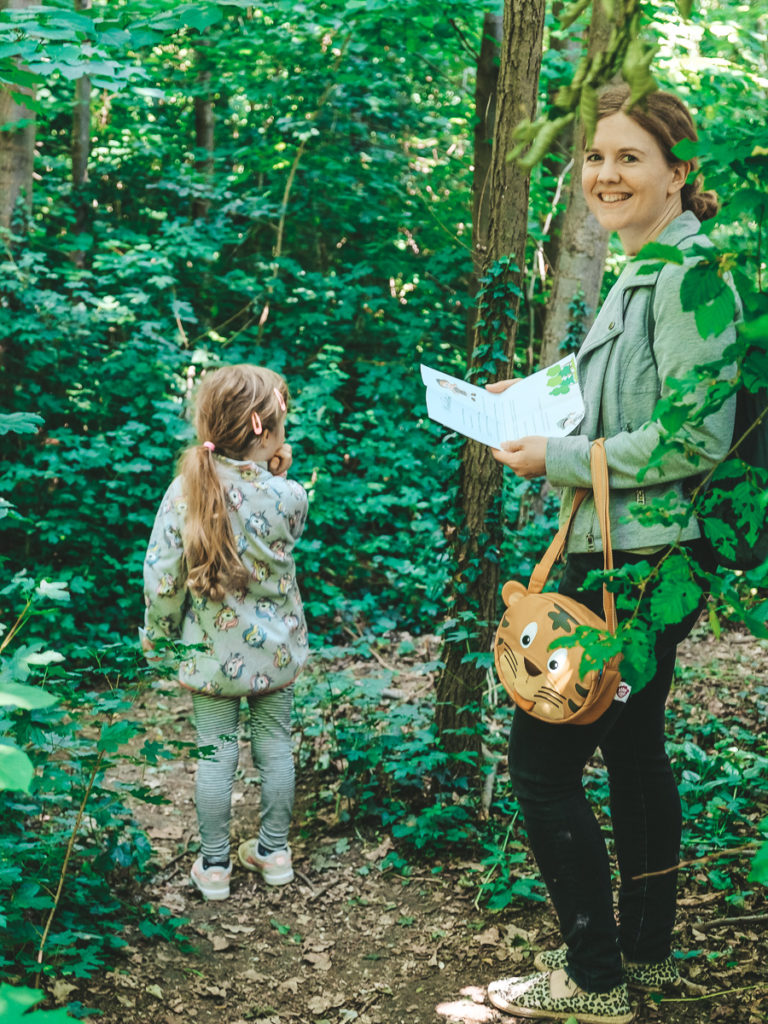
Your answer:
[144,456,308,696]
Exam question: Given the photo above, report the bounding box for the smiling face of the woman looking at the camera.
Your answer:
[582,113,689,255]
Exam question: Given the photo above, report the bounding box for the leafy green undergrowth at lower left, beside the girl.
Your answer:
[0,561,188,999]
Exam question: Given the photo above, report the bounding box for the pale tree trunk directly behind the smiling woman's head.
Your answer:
[541,3,624,367]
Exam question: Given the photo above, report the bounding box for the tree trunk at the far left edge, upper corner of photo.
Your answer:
[0,0,35,234]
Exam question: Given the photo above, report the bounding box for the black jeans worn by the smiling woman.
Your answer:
[509,544,700,992]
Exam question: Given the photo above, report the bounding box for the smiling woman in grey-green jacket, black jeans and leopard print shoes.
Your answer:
[488,86,735,1024]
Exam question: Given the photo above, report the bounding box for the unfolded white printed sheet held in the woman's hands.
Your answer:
[421,355,584,447]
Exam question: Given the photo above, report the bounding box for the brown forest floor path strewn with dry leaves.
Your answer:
[55,636,768,1024]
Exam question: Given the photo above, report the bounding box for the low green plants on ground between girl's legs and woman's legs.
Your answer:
[290,636,544,909]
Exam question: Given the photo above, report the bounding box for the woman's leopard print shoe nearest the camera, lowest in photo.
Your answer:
[488,971,635,1024]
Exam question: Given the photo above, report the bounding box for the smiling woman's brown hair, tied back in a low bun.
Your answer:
[597,83,720,220]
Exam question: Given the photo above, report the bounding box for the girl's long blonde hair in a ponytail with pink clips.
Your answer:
[179,362,289,601]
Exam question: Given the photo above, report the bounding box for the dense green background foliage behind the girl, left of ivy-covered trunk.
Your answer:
[0,2,481,642]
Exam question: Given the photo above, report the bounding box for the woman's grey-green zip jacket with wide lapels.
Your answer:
[546,211,739,552]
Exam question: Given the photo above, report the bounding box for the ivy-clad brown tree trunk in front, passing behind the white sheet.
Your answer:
[436,0,545,752]
